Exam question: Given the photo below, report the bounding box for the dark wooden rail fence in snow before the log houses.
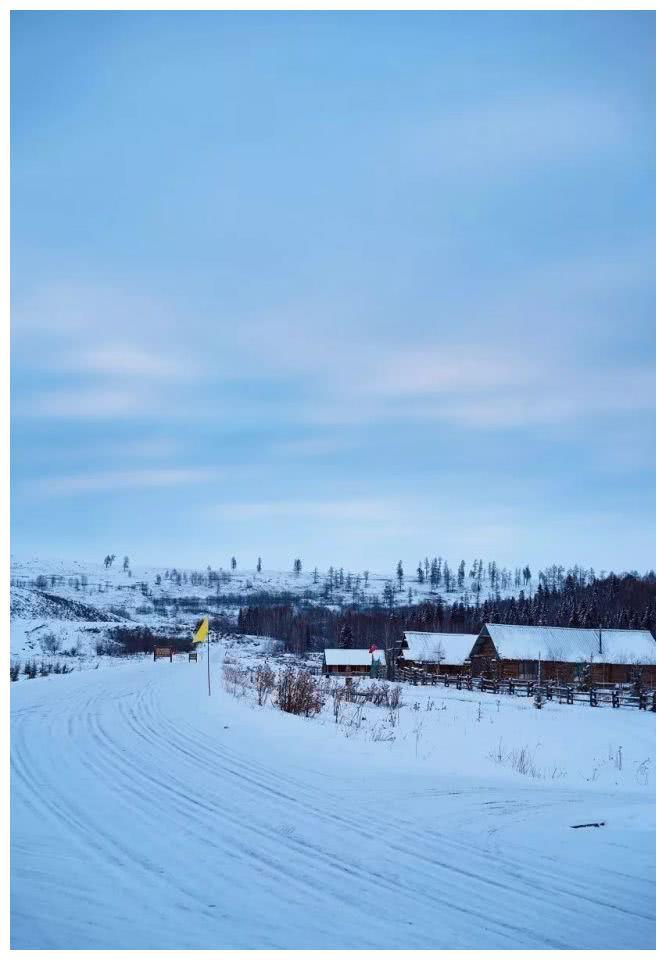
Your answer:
[396,667,657,713]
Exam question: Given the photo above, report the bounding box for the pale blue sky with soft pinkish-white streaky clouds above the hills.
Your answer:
[11,12,655,572]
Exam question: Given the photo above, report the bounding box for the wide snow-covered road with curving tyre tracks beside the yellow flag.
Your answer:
[11,659,655,949]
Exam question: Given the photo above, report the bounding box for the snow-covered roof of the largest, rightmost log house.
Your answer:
[482,623,656,663]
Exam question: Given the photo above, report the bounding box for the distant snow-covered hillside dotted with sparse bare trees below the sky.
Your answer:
[11,558,512,665]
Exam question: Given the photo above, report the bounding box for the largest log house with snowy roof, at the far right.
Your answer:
[470,623,657,687]
